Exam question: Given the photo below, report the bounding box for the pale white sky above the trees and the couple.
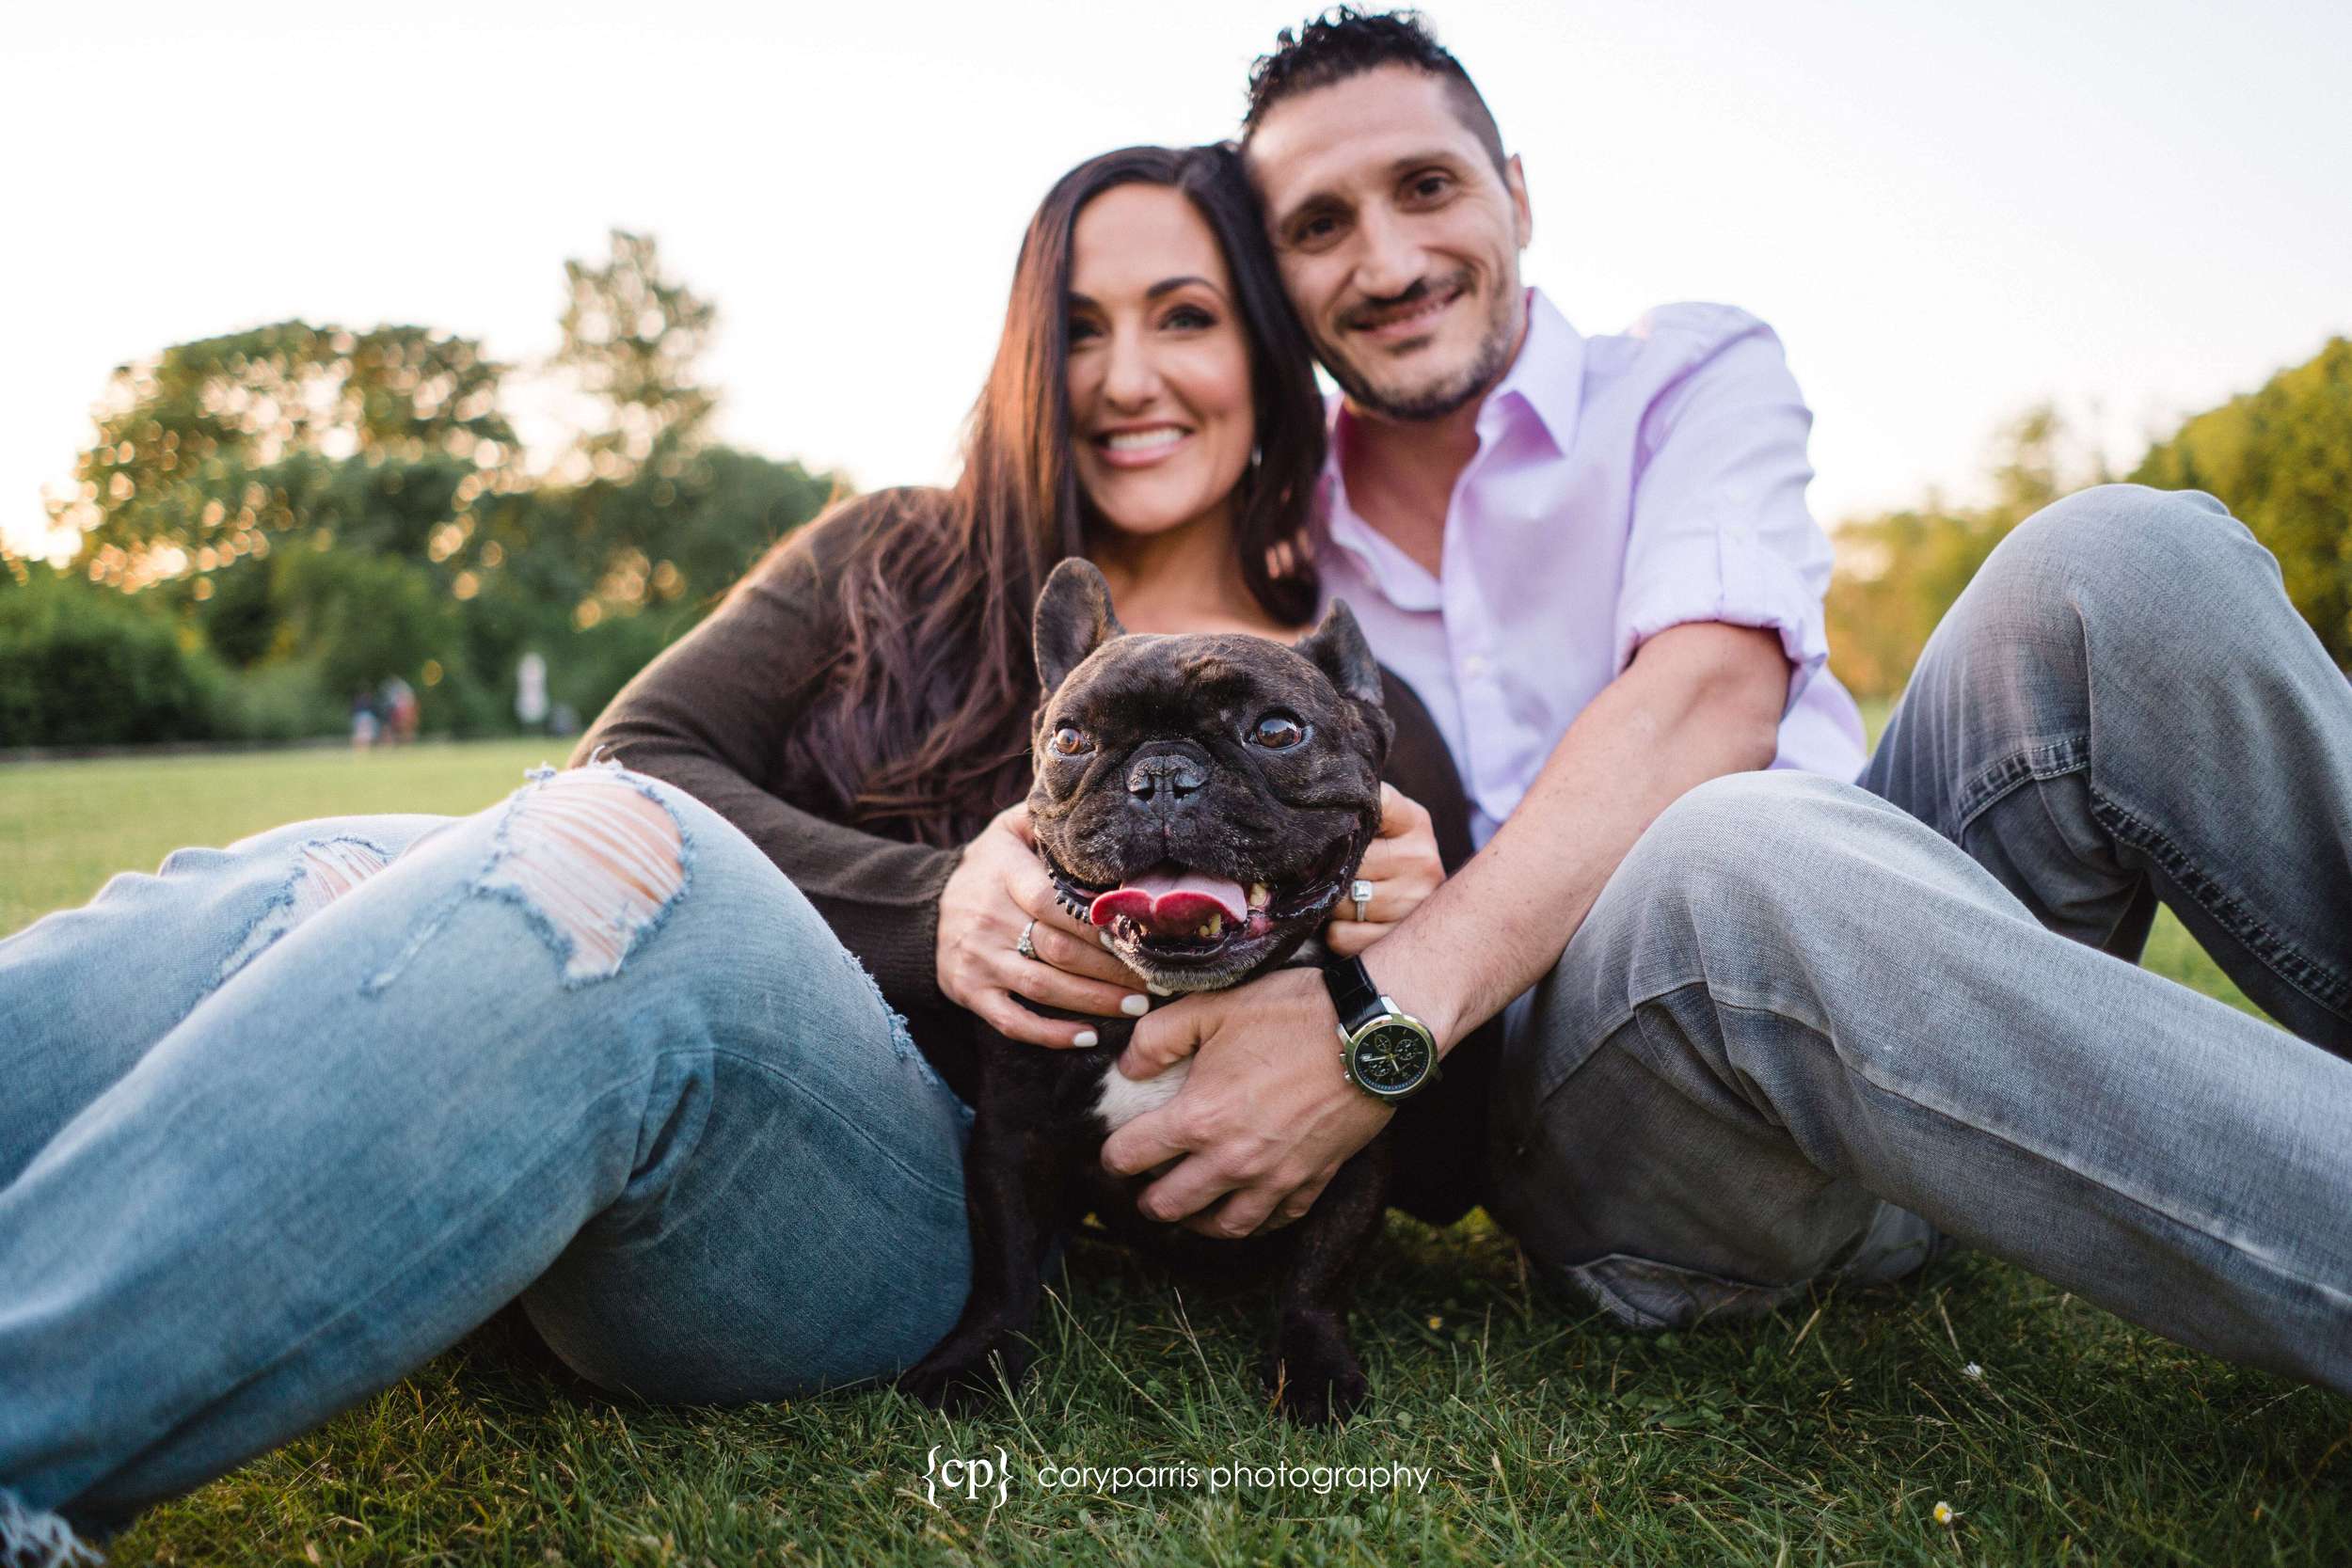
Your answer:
[0,0,2352,563]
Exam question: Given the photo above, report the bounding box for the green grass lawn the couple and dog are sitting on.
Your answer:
[0,743,2352,1566]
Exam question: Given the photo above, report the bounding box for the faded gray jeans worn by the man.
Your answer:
[1489,484,2352,1392]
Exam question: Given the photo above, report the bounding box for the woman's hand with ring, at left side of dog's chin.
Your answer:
[939,804,1151,1046]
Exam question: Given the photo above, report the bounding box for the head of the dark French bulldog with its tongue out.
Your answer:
[1030,560,1391,992]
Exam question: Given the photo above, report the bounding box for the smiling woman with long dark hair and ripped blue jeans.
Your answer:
[0,148,1475,1543]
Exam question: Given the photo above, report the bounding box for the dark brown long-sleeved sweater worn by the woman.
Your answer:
[572,491,1501,1223]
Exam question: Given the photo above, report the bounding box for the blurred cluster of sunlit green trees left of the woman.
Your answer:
[0,232,835,748]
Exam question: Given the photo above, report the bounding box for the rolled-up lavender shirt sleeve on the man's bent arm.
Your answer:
[1616,306,1833,717]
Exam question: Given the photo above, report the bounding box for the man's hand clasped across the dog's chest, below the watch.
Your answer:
[1104,969,1397,1237]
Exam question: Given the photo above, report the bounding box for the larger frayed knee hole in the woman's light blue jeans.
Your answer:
[362,764,687,997]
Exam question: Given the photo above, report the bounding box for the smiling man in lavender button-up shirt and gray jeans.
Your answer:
[1104,11,2352,1389]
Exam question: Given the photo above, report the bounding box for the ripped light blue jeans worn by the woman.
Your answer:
[0,764,972,1561]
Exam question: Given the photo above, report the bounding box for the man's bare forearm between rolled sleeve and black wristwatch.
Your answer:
[1364,623,1788,1049]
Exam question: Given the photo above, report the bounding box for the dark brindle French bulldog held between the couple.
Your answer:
[898,560,1392,1422]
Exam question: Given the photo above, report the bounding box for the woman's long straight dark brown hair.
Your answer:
[786,146,1325,844]
